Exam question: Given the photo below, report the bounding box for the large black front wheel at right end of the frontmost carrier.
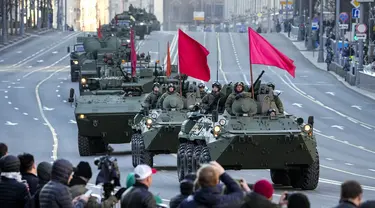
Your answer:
[289,150,320,190]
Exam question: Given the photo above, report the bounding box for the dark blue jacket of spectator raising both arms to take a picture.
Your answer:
[180,173,244,208]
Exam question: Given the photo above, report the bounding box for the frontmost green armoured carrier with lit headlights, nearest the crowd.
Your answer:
[177,75,319,190]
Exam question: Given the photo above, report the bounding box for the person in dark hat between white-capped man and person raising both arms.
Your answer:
[169,174,196,208]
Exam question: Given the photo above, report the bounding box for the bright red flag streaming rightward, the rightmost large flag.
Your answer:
[248,27,296,77]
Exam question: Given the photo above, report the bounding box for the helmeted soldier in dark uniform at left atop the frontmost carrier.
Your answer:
[202,82,224,113]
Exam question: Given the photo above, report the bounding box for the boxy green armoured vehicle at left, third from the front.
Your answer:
[74,57,177,156]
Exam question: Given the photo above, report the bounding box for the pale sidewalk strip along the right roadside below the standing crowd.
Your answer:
[281,33,375,100]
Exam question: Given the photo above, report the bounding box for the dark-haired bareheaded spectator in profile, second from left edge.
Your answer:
[18,153,39,196]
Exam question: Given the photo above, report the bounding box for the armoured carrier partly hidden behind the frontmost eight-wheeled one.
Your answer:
[131,77,201,167]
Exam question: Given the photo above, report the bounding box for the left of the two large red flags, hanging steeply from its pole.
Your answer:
[178,30,210,82]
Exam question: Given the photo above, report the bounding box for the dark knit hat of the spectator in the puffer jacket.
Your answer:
[51,159,73,184]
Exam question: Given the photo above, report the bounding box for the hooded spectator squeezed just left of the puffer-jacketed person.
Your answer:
[33,162,52,208]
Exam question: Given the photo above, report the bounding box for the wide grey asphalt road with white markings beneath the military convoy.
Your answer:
[0,32,375,207]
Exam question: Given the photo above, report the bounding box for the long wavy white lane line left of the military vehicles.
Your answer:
[35,66,70,161]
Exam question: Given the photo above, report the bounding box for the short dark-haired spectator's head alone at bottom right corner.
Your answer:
[336,181,363,208]
